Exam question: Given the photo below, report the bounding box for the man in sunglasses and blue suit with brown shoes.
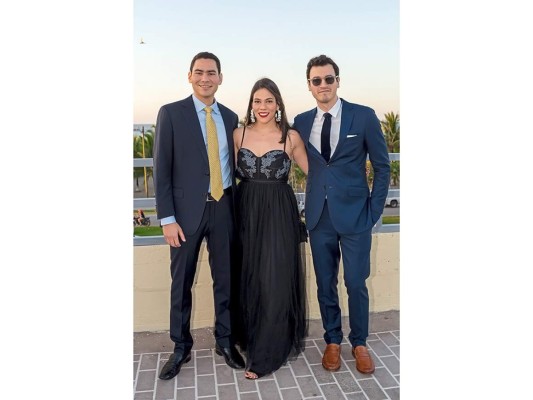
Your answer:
[294,55,390,374]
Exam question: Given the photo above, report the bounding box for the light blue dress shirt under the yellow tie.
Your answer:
[161,95,233,225]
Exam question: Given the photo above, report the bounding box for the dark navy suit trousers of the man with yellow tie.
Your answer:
[170,195,234,353]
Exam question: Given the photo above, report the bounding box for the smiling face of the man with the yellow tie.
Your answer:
[189,58,222,105]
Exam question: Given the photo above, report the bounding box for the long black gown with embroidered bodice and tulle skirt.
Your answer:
[233,148,308,376]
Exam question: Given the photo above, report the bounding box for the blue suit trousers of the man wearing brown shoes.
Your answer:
[309,202,372,347]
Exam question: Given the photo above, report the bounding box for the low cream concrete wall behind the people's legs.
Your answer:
[133,232,400,332]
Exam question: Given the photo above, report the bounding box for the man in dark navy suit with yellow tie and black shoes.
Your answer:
[154,52,244,380]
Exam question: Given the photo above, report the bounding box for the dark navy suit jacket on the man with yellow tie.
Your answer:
[154,96,239,235]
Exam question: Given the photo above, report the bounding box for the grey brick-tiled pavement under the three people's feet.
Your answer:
[133,311,400,400]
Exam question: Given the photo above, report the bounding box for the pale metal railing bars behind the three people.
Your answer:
[133,153,400,246]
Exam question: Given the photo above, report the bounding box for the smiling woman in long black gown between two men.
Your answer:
[233,78,307,379]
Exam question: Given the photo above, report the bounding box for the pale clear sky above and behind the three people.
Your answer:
[133,0,400,124]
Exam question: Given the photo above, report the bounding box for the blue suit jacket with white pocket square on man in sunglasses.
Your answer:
[294,99,390,234]
